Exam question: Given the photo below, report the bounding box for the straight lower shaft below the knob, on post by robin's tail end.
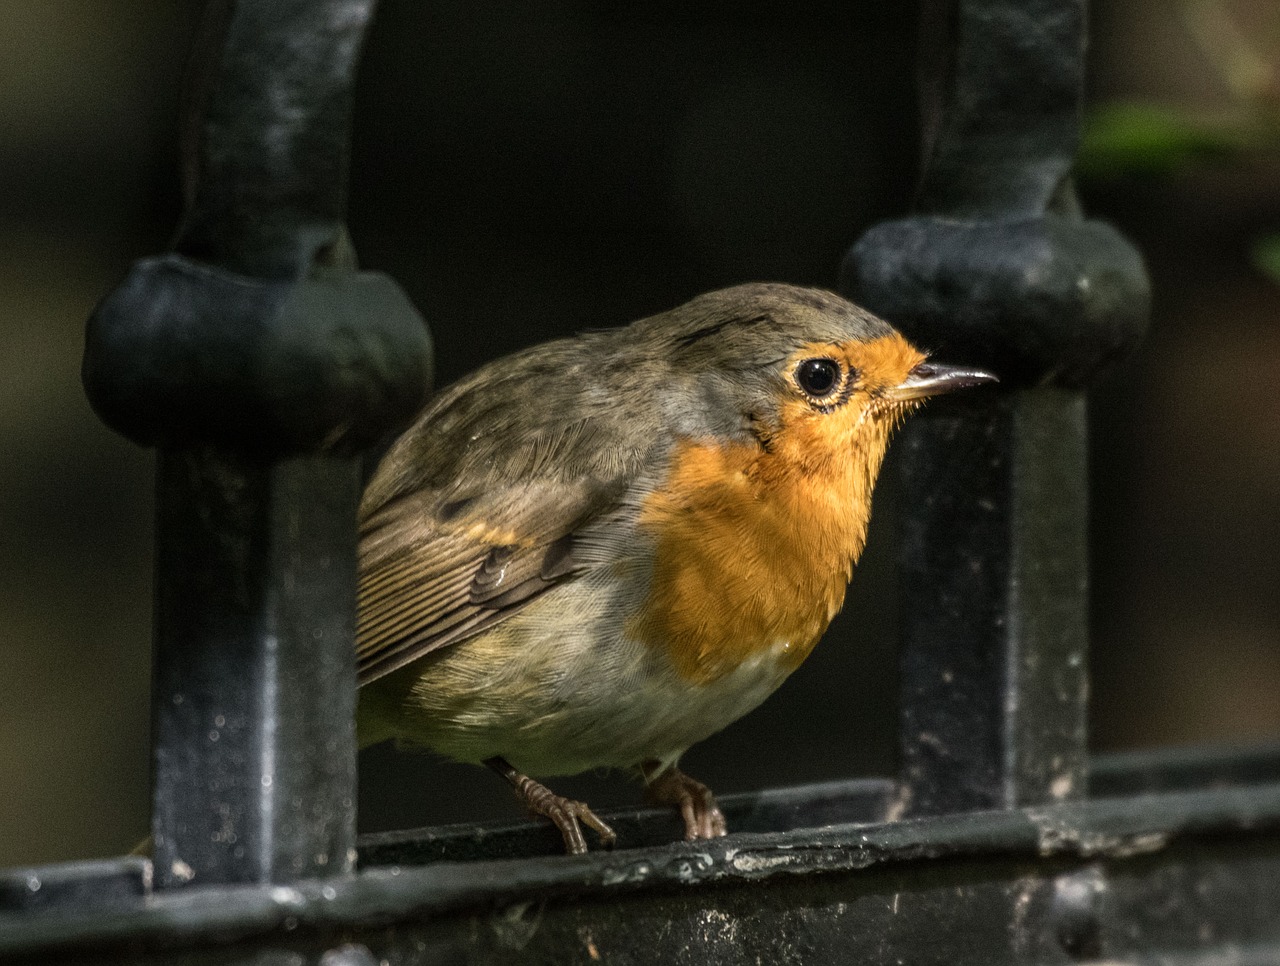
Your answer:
[152,449,360,884]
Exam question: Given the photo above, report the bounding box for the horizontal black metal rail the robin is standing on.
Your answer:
[0,747,1280,962]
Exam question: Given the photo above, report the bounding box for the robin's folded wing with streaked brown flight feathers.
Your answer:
[356,481,629,685]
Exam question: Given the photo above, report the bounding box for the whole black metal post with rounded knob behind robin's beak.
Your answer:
[841,0,1148,814]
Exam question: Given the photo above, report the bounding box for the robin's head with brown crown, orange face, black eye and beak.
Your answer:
[632,284,996,475]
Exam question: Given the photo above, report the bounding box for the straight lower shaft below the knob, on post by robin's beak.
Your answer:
[899,389,1088,812]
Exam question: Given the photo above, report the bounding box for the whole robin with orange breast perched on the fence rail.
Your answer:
[356,283,997,853]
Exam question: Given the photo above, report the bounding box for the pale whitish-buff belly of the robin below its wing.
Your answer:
[363,578,794,777]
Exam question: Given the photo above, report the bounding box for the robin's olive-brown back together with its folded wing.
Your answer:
[356,334,669,685]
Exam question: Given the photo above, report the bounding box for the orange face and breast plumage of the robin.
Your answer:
[628,335,924,683]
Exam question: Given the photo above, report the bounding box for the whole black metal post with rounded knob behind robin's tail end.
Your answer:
[84,0,430,887]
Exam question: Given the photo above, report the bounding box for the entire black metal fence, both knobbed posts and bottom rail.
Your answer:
[0,0,1280,963]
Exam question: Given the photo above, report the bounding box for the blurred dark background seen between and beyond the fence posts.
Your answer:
[0,0,1280,866]
